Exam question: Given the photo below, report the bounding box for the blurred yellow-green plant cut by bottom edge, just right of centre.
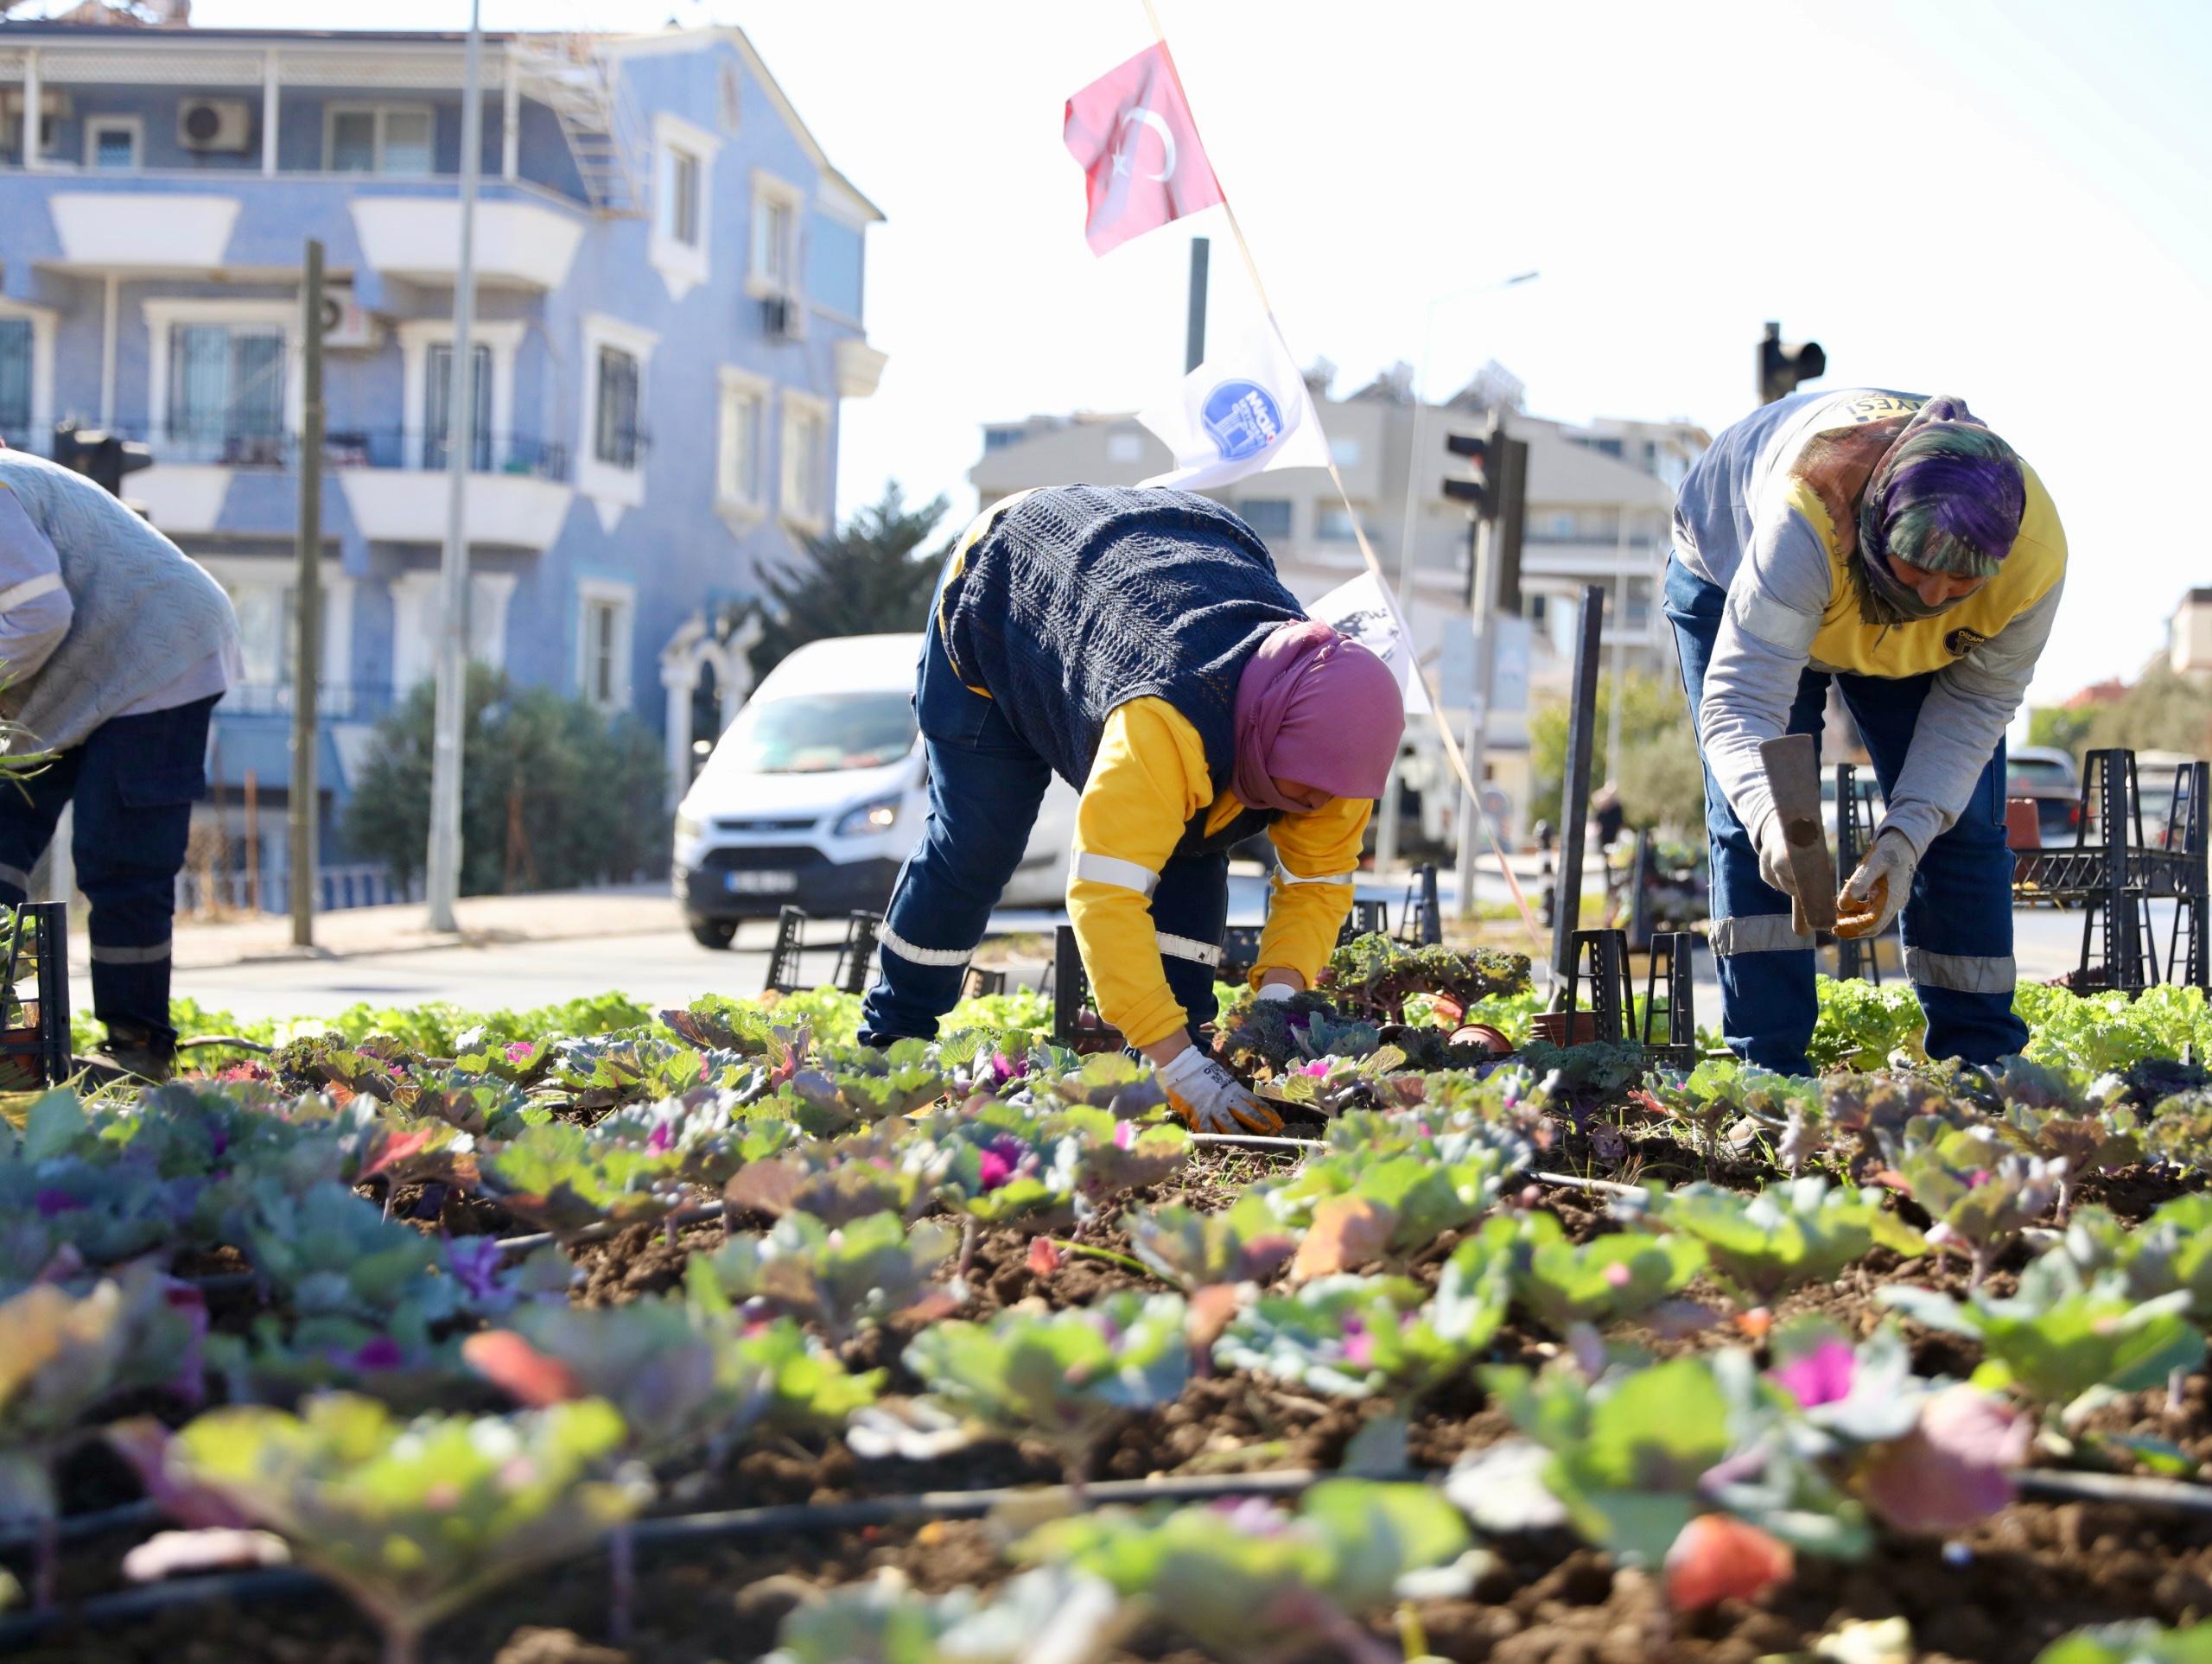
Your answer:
[1013,1478,1484,1660]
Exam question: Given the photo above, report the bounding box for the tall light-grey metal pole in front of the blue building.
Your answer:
[423,0,485,930]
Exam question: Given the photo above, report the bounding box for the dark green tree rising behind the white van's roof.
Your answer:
[750,480,949,677]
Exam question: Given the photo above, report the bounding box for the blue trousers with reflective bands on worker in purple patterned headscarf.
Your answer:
[1666,560,2029,1073]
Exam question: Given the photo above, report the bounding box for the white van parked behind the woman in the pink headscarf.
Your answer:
[675,635,1075,947]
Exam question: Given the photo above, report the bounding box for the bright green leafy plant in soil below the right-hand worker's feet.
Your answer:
[1642,1178,1927,1305]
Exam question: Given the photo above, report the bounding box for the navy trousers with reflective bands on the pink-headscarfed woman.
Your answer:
[861,624,1230,1046]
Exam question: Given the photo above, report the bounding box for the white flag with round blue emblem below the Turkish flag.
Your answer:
[1137,319,1330,492]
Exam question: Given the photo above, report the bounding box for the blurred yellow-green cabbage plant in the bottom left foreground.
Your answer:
[166,1394,651,1664]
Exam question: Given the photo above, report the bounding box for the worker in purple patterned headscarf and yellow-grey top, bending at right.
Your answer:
[1666,387,2066,1073]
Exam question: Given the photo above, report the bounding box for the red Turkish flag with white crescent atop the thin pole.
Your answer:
[1059,40,1221,255]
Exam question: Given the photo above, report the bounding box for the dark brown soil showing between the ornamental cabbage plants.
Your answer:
[21,1140,2212,1664]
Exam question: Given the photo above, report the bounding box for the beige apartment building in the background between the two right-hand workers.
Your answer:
[969,365,1710,836]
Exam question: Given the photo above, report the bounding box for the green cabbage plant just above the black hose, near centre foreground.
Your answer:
[905,1292,1190,1485]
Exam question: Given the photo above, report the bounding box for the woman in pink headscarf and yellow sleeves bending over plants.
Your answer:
[861,485,1405,1131]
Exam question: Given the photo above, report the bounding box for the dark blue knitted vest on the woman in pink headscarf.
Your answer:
[940,485,1305,801]
